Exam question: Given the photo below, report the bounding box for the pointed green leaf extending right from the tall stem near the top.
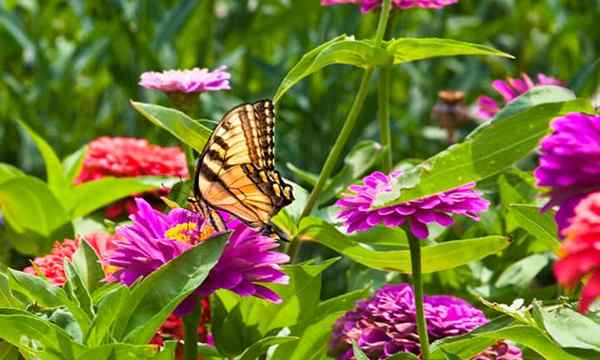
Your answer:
[387,38,514,64]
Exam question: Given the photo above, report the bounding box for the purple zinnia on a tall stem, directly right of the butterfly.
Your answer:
[336,171,489,239]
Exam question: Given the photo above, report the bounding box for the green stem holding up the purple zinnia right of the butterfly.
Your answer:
[408,236,429,360]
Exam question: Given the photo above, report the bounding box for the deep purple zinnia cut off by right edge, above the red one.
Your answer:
[534,113,600,233]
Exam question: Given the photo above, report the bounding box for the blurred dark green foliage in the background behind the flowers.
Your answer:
[0,0,600,179]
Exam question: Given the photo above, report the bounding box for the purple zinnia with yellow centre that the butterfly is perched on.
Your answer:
[104,198,289,315]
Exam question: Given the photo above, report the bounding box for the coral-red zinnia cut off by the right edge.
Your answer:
[554,192,600,313]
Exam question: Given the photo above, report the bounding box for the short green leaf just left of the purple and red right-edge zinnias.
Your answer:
[510,204,560,251]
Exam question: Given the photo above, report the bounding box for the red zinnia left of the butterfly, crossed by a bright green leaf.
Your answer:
[75,136,189,219]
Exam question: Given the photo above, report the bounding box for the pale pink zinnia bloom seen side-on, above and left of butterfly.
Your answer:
[139,66,231,94]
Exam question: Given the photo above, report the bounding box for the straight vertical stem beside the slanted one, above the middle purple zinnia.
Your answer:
[377,66,394,173]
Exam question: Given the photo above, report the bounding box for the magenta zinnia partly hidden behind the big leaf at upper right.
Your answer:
[477,73,563,120]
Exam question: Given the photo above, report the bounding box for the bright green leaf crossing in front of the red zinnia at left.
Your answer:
[68,176,178,219]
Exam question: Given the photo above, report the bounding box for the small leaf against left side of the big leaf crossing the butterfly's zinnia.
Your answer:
[85,285,129,347]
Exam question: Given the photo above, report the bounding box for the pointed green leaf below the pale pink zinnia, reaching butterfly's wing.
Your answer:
[131,101,212,152]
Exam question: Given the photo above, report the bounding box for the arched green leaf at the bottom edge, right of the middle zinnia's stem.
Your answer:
[431,317,579,360]
